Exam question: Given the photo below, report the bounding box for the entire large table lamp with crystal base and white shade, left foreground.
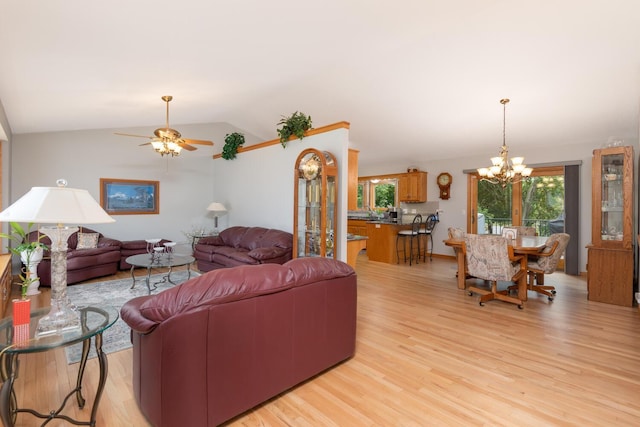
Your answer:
[0,179,115,338]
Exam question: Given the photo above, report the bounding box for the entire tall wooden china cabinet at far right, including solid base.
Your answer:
[587,146,634,306]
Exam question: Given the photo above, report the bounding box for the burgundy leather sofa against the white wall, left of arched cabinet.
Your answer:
[193,226,293,271]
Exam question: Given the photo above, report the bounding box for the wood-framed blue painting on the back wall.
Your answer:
[100,178,160,215]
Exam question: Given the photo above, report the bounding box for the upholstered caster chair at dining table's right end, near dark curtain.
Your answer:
[509,233,570,301]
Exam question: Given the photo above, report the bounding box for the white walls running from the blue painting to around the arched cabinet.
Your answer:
[7,123,349,259]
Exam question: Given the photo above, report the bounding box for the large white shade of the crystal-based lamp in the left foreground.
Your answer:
[0,187,115,224]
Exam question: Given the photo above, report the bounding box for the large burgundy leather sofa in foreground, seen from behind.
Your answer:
[120,258,357,427]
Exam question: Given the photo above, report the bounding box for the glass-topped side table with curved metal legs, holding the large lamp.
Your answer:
[0,307,119,427]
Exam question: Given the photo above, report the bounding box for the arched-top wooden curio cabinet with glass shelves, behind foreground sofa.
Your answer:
[293,148,338,258]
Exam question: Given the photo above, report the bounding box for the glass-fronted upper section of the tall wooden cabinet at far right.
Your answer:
[592,147,633,248]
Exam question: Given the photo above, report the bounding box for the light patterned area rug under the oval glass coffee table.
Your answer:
[65,270,200,364]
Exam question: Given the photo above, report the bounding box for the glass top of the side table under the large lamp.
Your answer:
[0,306,119,353]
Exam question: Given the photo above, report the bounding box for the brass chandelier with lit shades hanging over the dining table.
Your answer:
[478,98,533,187]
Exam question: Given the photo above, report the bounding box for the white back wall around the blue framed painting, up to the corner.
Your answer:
[11,124,226,251]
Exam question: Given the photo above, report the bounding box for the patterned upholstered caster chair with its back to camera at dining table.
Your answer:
[463,234,527,309]
